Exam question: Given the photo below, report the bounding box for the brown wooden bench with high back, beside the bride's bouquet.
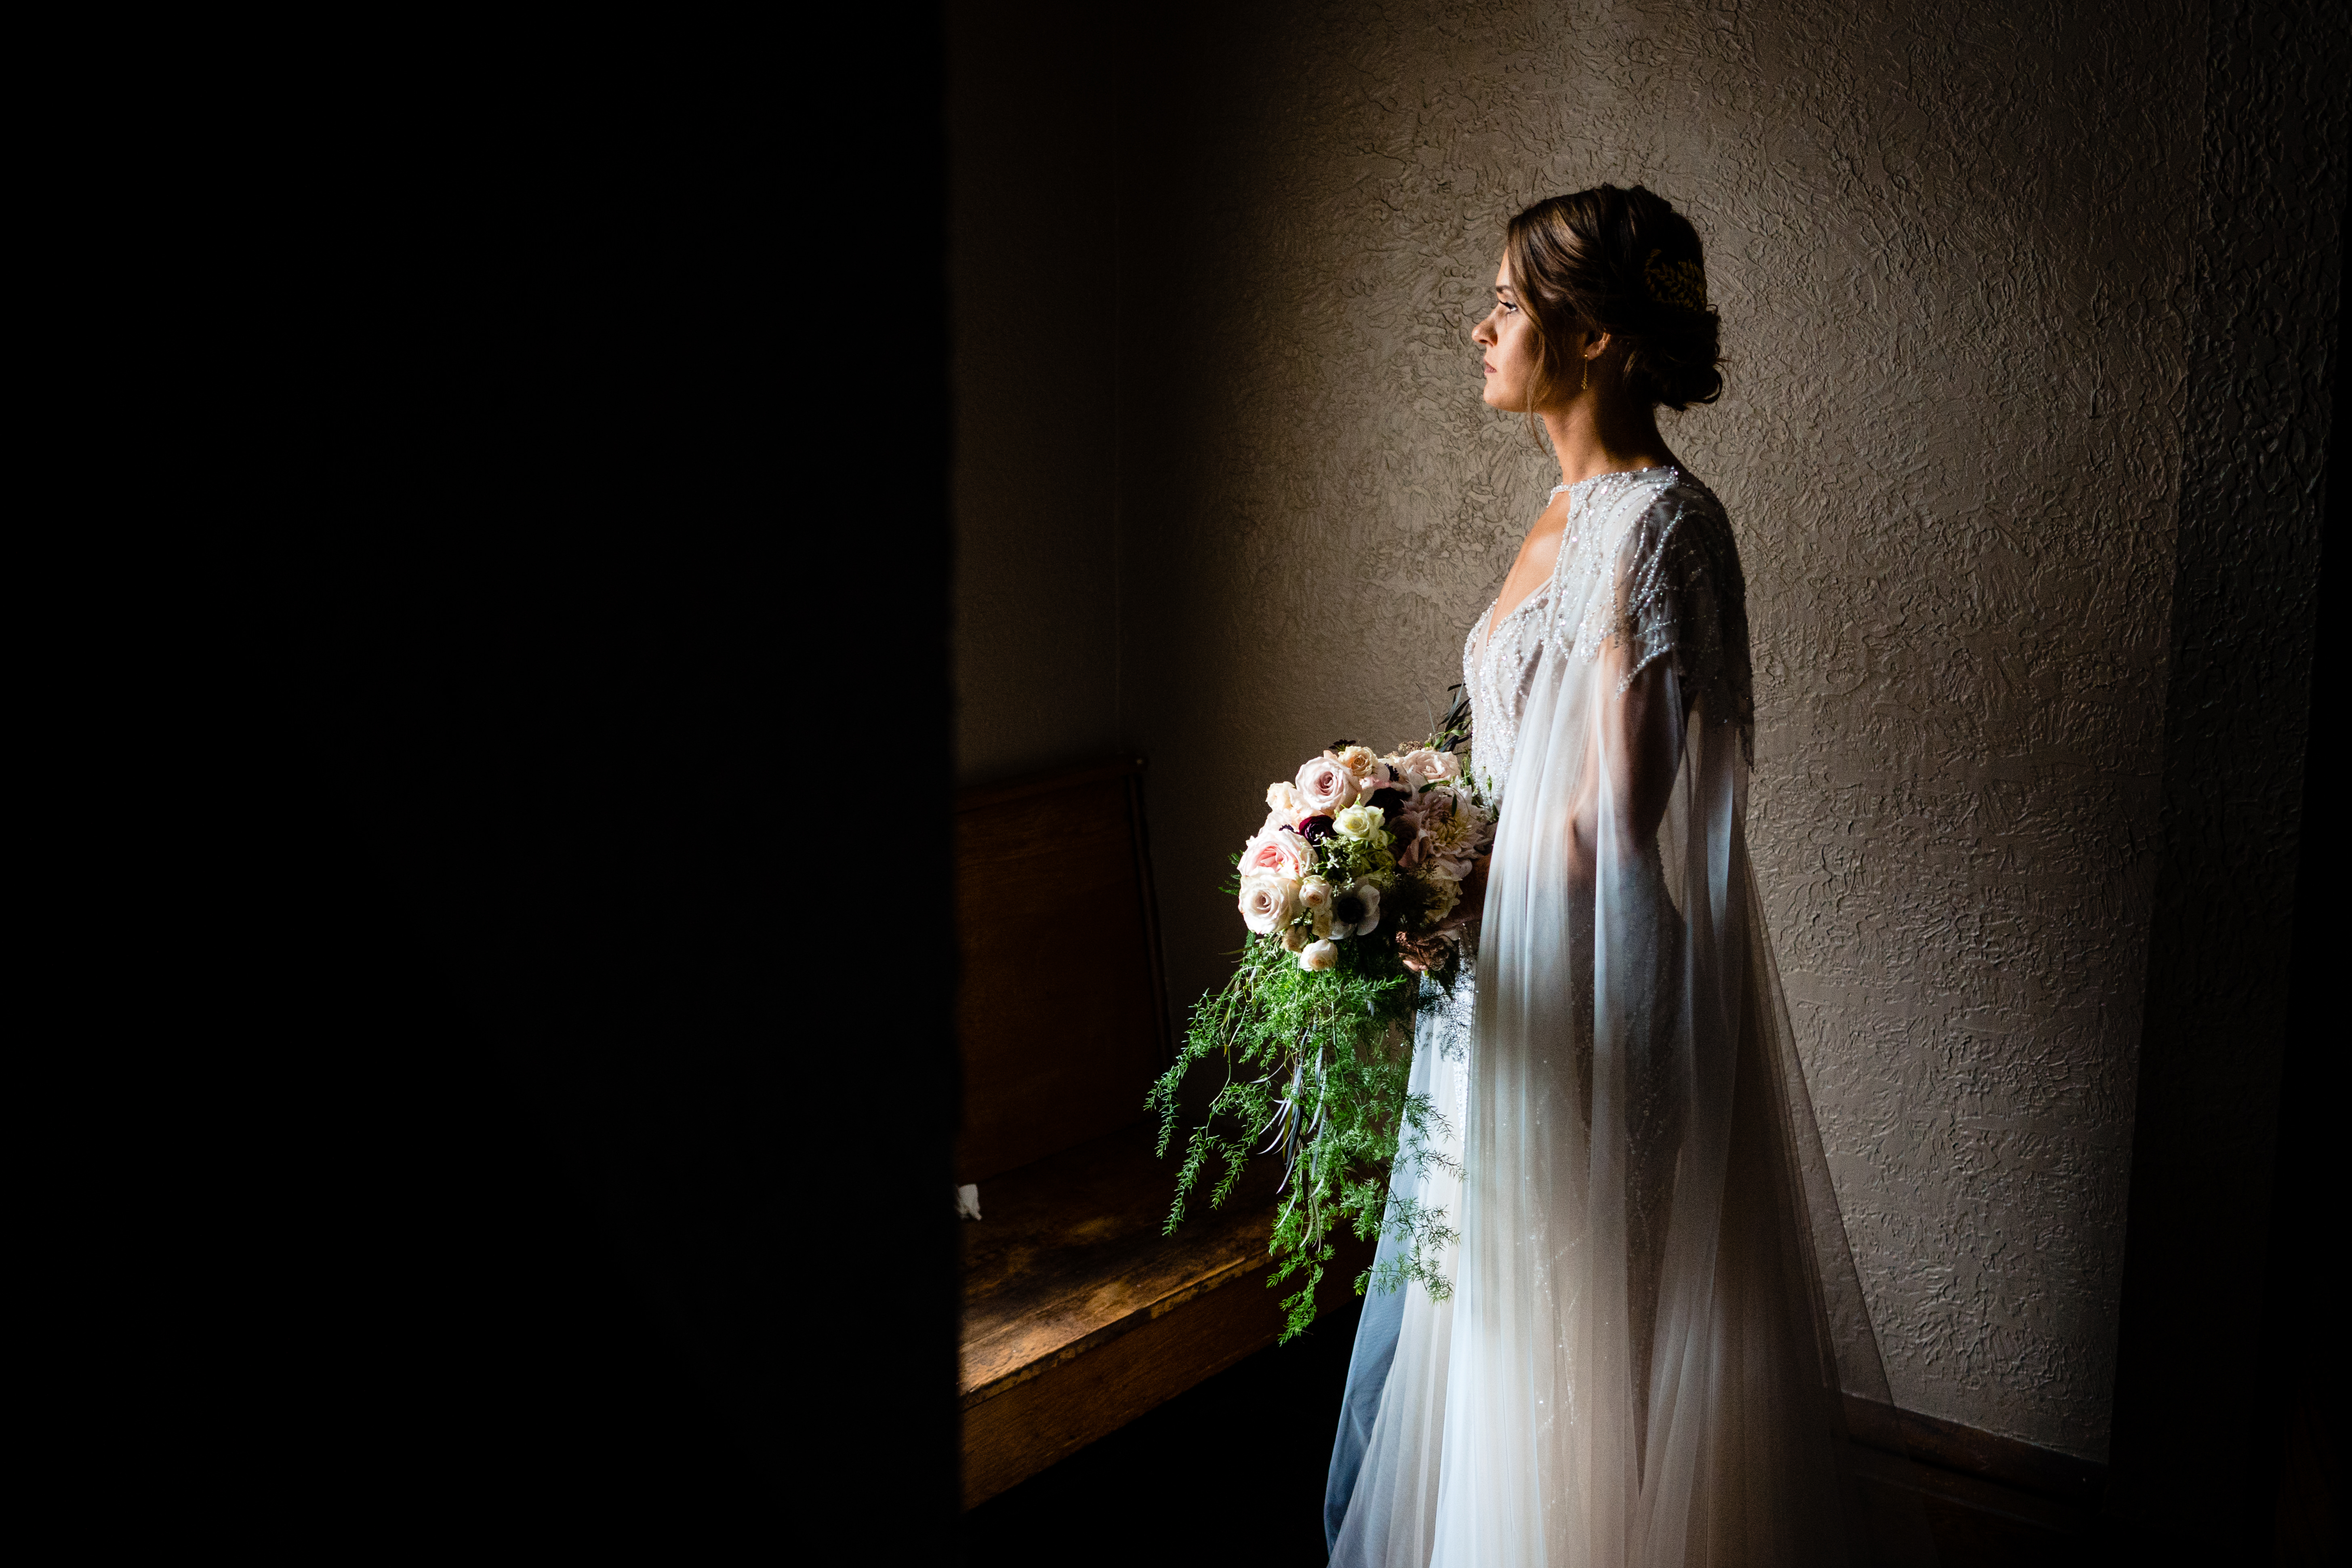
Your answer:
[955,762,1371,1507]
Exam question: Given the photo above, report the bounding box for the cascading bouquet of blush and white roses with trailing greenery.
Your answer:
[1150,701,1496,1340]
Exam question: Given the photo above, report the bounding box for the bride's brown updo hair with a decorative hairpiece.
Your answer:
[1503,186,1724,411]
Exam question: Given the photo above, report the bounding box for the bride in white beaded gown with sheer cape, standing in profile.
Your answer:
[1324,186,1929,1568]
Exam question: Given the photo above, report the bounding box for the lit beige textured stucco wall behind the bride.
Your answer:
[1119,0,2204,1458]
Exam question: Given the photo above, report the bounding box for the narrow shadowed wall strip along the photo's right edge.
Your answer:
[2105,0,2352,1561]
